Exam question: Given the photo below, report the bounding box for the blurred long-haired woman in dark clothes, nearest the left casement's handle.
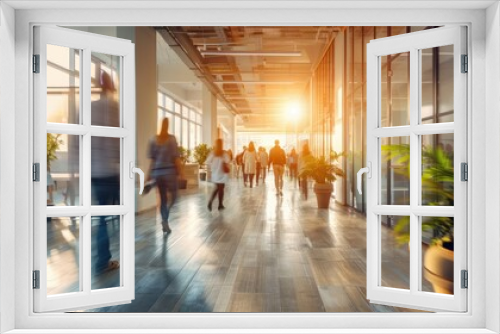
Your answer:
[147,118,185,233]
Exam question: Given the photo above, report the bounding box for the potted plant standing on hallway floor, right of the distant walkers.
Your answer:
[299,151,344,209]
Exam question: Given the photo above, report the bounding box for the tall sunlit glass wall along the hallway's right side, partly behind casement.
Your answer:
[306,26,430,212]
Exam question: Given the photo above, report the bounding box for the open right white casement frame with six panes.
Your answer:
[366,26,468,312]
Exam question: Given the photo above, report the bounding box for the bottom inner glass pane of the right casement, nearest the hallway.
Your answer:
[380,216,410,289]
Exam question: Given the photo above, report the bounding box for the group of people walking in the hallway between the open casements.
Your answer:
[146,118,312,237]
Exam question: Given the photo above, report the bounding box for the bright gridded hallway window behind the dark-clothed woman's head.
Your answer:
[158,91,202,150]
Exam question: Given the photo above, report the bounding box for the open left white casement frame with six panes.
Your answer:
[33,25,136,312]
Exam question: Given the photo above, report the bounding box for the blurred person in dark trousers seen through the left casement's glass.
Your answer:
[91,71,120,273]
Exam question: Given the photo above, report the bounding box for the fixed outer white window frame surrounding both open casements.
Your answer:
[0,1,500,333]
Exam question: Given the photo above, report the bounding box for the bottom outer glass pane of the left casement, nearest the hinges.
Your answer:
[47,217,80,295]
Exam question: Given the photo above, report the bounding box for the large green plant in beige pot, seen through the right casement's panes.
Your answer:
[383,145,454,294]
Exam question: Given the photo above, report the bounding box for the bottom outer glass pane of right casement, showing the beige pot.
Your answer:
[422,217,454,295]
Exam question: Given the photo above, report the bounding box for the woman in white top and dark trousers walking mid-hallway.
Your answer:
[207,139,231,211]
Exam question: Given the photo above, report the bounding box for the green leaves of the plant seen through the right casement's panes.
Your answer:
[382,144,454,245]
